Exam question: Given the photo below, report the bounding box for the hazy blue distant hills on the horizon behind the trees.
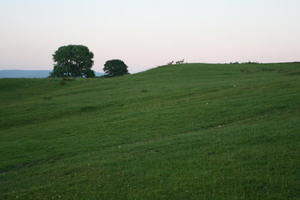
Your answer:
[0,70,103,78]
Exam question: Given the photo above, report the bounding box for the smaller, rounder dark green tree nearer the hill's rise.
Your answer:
[103,59,128,77]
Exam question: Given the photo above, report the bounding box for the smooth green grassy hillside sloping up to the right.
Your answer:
[0,63,300,200]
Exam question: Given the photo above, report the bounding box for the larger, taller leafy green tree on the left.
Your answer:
[50,45,95,78]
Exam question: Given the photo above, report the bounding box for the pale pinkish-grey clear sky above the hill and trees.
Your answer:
[0,0,300,73]
